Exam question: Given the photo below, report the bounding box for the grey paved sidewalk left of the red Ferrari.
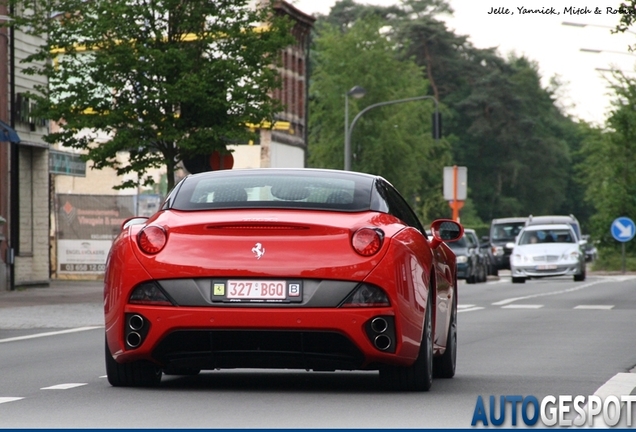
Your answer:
[0,279,104,329]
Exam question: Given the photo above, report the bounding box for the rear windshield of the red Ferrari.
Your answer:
[171,172,372,211]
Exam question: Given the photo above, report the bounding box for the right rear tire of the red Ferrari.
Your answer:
[380,291,433,391]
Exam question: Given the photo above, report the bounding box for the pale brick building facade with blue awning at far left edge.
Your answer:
[0,5,50,289]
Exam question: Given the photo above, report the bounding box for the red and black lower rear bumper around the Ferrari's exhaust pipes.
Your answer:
[107,305,417,370]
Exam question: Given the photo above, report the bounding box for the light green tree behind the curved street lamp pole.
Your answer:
[309,16,450,220]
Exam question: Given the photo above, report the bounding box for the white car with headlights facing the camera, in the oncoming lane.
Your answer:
[510,224,585,283]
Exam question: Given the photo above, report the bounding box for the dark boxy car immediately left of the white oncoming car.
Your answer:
[483,217,527,276]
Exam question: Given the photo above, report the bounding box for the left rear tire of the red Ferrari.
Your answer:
[104,336,161,387]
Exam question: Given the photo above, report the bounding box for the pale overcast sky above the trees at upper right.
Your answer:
[287,0,636,125]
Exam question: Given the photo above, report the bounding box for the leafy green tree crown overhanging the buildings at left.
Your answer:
[10,0,293,189]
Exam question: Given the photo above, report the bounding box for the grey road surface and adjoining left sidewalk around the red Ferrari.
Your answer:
[0,275,636,428]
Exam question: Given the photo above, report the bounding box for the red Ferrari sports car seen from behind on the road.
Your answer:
[104,169,463,391]
